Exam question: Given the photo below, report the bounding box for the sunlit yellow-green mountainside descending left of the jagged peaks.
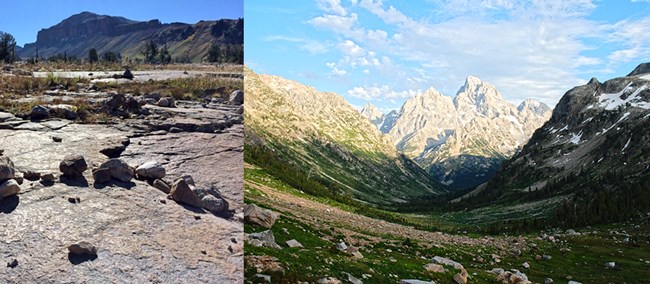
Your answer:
[244,69,440,204]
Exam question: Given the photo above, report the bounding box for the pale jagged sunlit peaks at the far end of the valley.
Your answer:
[366,76,551,188]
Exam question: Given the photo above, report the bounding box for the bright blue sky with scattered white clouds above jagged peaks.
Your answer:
[244,0,650,111]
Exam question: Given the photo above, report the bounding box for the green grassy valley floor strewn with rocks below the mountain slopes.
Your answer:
[245,165,650,283]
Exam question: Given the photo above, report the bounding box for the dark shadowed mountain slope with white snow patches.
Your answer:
[470,64,650,226]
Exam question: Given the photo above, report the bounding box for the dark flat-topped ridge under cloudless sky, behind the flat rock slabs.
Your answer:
[18,12,244,62]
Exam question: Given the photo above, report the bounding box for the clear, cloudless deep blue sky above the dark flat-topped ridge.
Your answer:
[0,0,244,46]
